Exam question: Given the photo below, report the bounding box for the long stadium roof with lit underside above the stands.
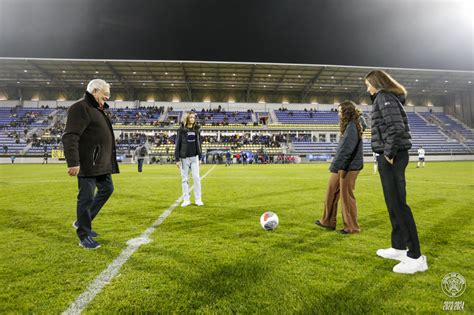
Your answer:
[0,58,474,100]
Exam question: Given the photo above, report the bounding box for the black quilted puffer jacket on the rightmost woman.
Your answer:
[371,91,411,159]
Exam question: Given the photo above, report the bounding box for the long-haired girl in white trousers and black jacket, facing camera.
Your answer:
[174,112,204,207]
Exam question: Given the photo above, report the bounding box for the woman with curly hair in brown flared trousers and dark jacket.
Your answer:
[315,101,364,234]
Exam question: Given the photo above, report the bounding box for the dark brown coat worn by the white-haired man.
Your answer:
[62,92,119,176]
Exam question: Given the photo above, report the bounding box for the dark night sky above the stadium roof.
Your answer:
[0,0,474,70]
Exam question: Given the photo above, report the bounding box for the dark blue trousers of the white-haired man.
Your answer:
[77,174,114,240]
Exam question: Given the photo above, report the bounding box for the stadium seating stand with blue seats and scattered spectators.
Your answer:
[0,107,474,160]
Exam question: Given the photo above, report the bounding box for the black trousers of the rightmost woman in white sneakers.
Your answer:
[379,151,421,259]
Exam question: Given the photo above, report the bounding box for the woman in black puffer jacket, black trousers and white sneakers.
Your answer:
[365,70,428,274]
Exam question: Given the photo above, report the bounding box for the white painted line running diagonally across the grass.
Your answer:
[63,165,216,315]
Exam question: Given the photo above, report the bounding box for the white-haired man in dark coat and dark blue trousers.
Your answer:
[62,79,119,249]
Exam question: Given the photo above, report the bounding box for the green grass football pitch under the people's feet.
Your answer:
[0,162,474,314]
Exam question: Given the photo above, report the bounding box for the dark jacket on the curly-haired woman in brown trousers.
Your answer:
[329,121,364,173]
